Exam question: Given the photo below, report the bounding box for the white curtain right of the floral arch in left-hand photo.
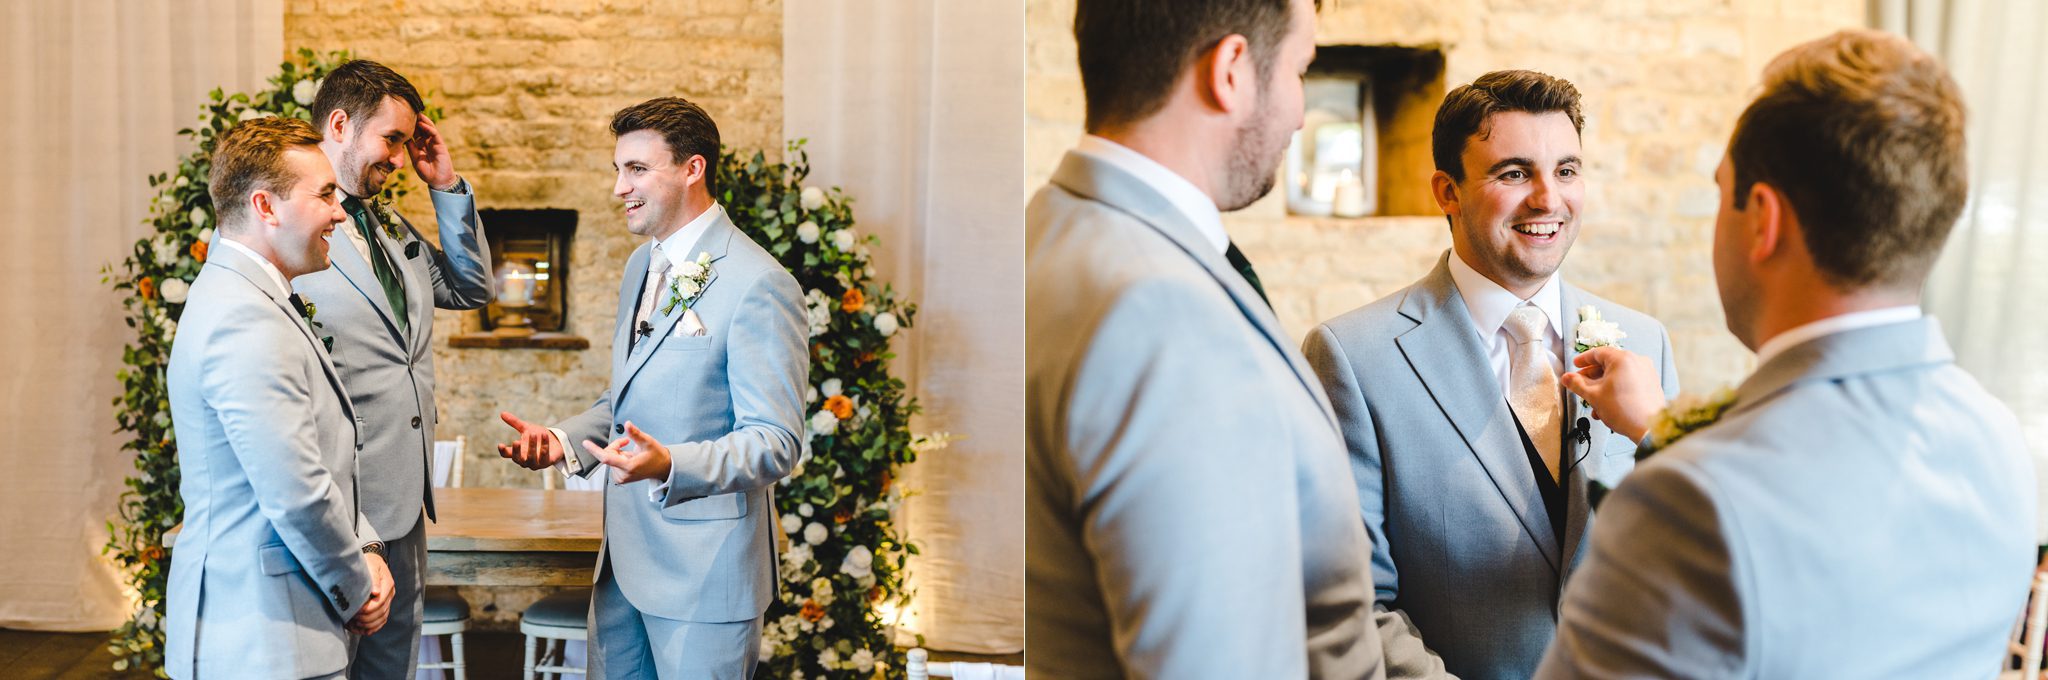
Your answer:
[782,0,1024,653]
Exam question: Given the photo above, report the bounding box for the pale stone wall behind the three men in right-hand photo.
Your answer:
[1026,0,1866,391]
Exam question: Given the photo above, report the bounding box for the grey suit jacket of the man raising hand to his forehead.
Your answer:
[291,180,492,539]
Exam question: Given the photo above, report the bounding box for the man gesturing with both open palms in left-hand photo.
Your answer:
[498,96,811,680]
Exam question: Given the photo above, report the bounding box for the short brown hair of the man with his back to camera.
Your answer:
[1729,31,1970,289]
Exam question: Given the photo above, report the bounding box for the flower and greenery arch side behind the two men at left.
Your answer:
[102,49,440,678]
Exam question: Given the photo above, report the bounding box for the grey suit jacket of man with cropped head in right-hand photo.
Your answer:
[1024,154,1382,678]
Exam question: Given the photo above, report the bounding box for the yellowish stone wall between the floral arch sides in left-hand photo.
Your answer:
[285,0,782,629]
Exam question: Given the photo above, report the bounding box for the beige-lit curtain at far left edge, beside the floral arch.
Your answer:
[0,0,285,631]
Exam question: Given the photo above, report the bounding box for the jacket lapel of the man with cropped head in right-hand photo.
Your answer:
[1053,152,1337,428]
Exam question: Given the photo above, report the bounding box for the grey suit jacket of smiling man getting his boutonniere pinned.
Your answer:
[1303,252,1677,678]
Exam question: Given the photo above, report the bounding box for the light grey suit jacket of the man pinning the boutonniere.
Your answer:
[1538,317,2036,678]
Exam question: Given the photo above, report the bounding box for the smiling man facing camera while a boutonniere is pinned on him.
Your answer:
[1303,72,1677,680]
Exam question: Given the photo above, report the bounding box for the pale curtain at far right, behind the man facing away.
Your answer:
[1872,0,2048,543]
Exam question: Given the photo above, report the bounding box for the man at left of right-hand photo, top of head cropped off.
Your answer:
[1024,0,1382,678]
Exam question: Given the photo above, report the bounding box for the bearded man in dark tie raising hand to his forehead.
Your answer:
[293,59,492,680]
